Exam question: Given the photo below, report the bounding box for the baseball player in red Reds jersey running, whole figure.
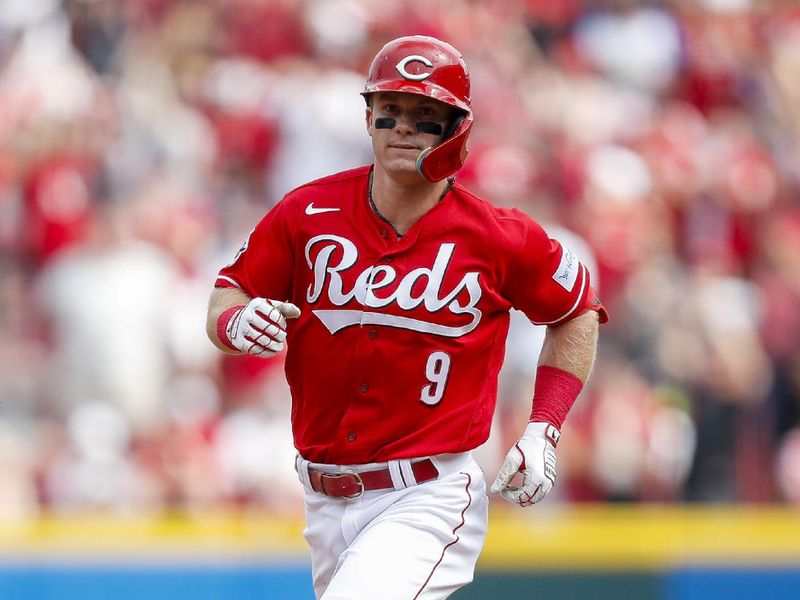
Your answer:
[208,36,606,600]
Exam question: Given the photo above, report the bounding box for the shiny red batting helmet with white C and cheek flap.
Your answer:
[361,35,473,181]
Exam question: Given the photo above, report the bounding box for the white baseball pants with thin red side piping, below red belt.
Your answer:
[297,452,489,600]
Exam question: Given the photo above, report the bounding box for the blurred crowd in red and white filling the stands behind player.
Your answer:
[0,0,800,516]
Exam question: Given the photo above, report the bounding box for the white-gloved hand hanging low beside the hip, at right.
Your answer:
[491,423,561,506]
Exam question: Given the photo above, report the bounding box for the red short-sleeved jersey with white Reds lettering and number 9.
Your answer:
[216,167,606,464]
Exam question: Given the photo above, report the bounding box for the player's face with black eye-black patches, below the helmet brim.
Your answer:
[367,92,455,177]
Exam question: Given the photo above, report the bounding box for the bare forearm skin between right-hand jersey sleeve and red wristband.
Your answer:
[539,310,600,383]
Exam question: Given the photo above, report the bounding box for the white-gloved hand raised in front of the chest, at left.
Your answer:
[225,298,300,358]
